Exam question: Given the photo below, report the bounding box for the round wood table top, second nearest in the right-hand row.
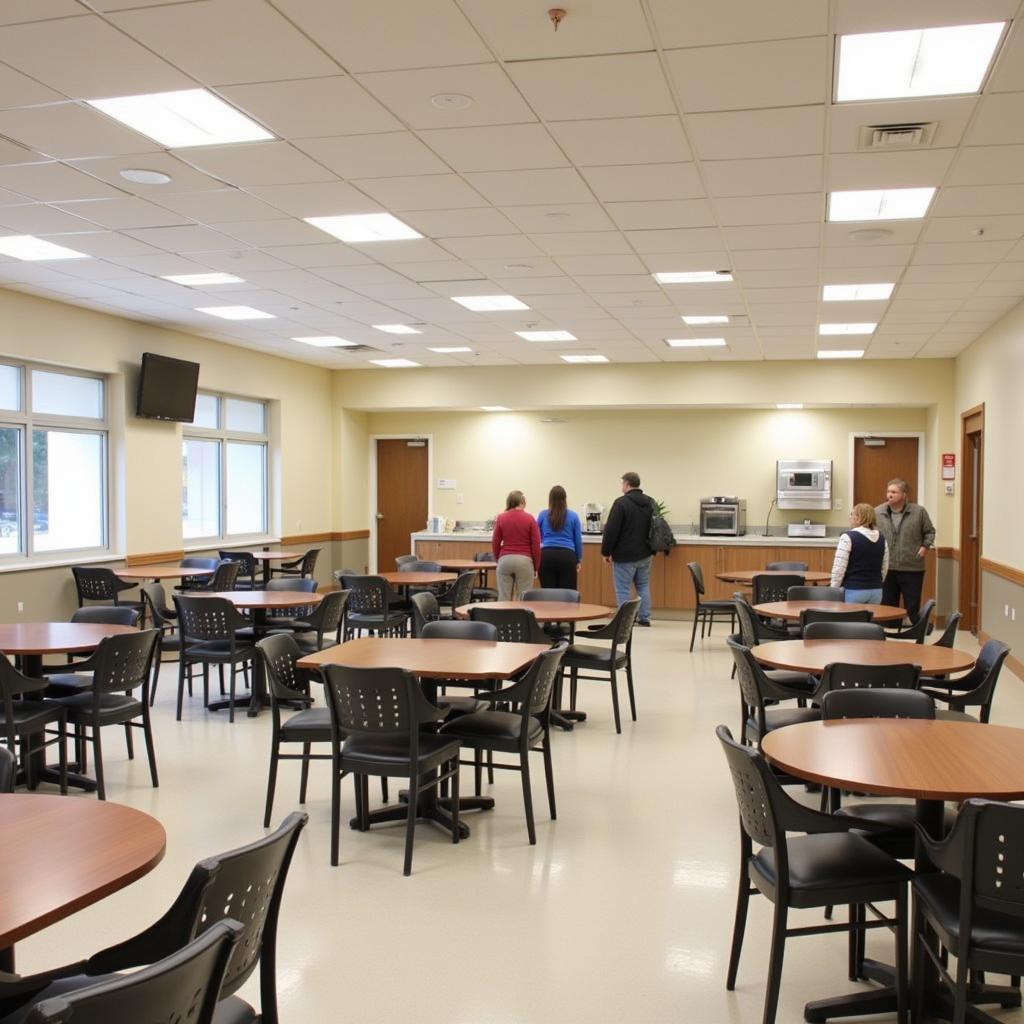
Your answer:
[751,640,974,676]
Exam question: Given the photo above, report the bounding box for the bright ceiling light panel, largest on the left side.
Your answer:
[86,89,273,150]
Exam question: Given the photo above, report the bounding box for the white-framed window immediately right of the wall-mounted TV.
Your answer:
[183,389,268,541]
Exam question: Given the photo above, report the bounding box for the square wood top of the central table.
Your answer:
[298,637,551,679]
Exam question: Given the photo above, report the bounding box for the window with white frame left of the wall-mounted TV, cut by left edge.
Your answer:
[0,362,109,560]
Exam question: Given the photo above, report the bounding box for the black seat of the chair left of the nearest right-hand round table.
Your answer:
[750,833,913,907]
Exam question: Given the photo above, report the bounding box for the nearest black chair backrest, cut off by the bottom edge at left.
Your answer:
[27,920,244,1024]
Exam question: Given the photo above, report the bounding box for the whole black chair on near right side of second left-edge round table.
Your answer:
[53,629,160,800]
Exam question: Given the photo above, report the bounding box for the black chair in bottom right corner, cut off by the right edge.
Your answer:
[911,800,1024,1024]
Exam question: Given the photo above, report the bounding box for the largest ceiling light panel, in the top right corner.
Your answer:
[836,22,1006,102]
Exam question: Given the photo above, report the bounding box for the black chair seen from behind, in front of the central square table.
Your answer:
[323,665,459,874]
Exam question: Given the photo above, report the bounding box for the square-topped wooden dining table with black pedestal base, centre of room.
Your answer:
[296,637,550,839]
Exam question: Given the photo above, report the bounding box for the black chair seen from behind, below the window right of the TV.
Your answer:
[174,594,256,722]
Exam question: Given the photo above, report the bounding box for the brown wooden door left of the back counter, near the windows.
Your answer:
[377,438,429,572]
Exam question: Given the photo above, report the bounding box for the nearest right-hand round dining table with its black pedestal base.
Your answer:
[755,720,1024,1021]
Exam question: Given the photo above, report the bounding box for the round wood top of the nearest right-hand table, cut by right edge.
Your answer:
[762,719,1024,800]
